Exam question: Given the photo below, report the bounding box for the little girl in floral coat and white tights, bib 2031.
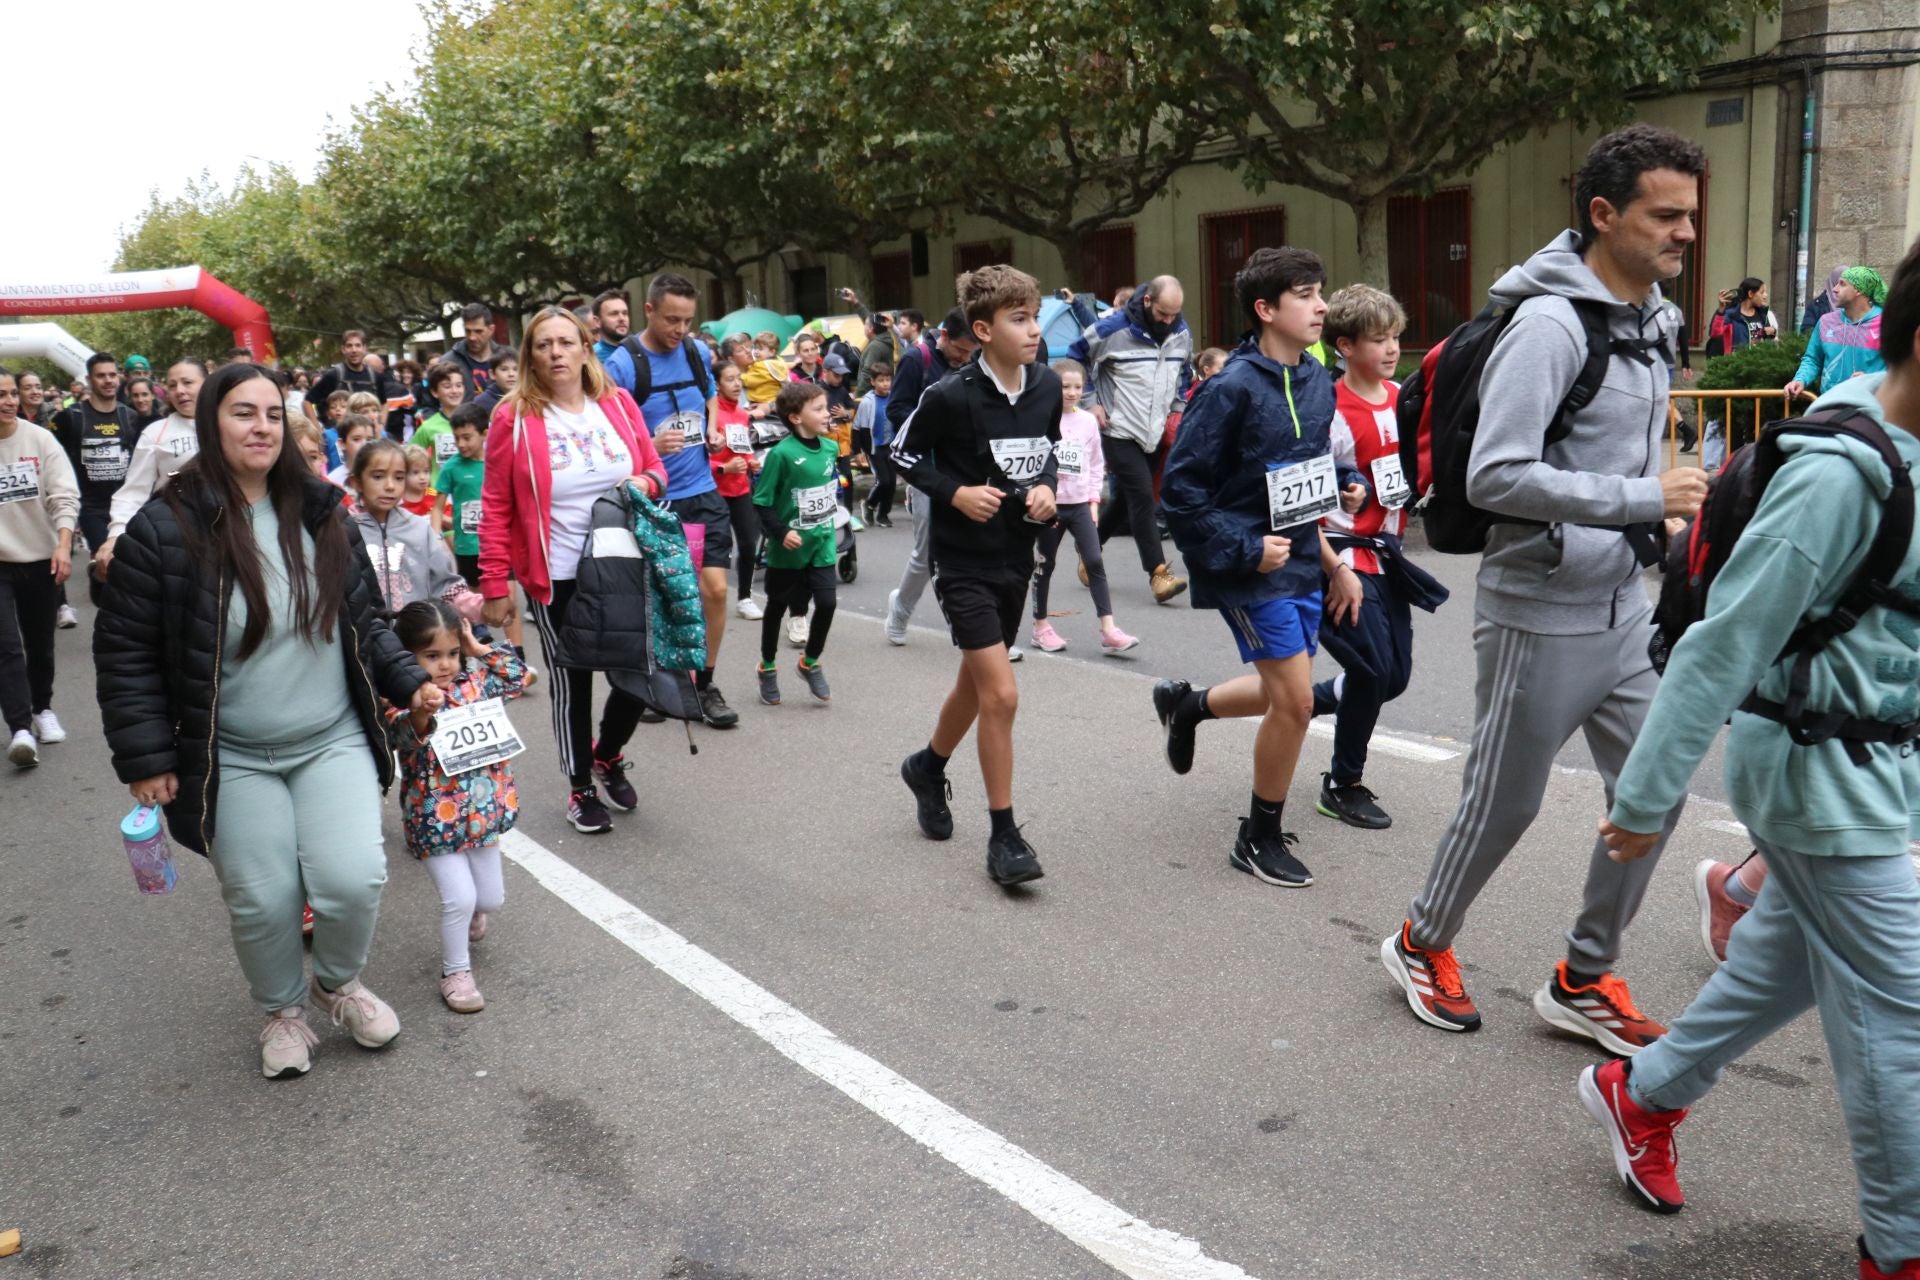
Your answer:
[386,601,526,1013]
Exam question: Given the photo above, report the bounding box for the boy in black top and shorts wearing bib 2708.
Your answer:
[893,265,1062,885]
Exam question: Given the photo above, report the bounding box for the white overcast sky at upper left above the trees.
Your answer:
[0,0,426,280]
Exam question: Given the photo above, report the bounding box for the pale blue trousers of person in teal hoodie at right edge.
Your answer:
[1630,841,1920,1270]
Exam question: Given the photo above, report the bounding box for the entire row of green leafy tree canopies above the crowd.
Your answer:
[45,0,1768,361]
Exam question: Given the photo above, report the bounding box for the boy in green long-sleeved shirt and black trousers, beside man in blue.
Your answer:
[753,382,839,706]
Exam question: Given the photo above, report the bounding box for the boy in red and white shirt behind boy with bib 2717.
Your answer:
[1313,284,1446,831]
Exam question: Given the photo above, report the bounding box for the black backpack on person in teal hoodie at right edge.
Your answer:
[1647,411,1920,764]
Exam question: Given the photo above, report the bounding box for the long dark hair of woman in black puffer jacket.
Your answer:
[167,361,351,658]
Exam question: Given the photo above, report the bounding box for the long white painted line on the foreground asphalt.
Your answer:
[499,831,1252,1280]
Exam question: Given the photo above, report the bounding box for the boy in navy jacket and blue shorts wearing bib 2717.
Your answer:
[1154,248,1367,889]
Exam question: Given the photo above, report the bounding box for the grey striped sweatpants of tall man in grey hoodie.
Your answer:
[1407,618,1684,975]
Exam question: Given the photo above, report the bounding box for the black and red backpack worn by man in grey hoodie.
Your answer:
[1394,299,1665,564]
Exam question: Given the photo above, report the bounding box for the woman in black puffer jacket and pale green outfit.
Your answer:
[94,365,440,1077]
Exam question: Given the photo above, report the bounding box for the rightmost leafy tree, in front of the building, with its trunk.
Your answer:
[1198,0,1772,288]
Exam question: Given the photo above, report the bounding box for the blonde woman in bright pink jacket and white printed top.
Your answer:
[480,307,666,833]
